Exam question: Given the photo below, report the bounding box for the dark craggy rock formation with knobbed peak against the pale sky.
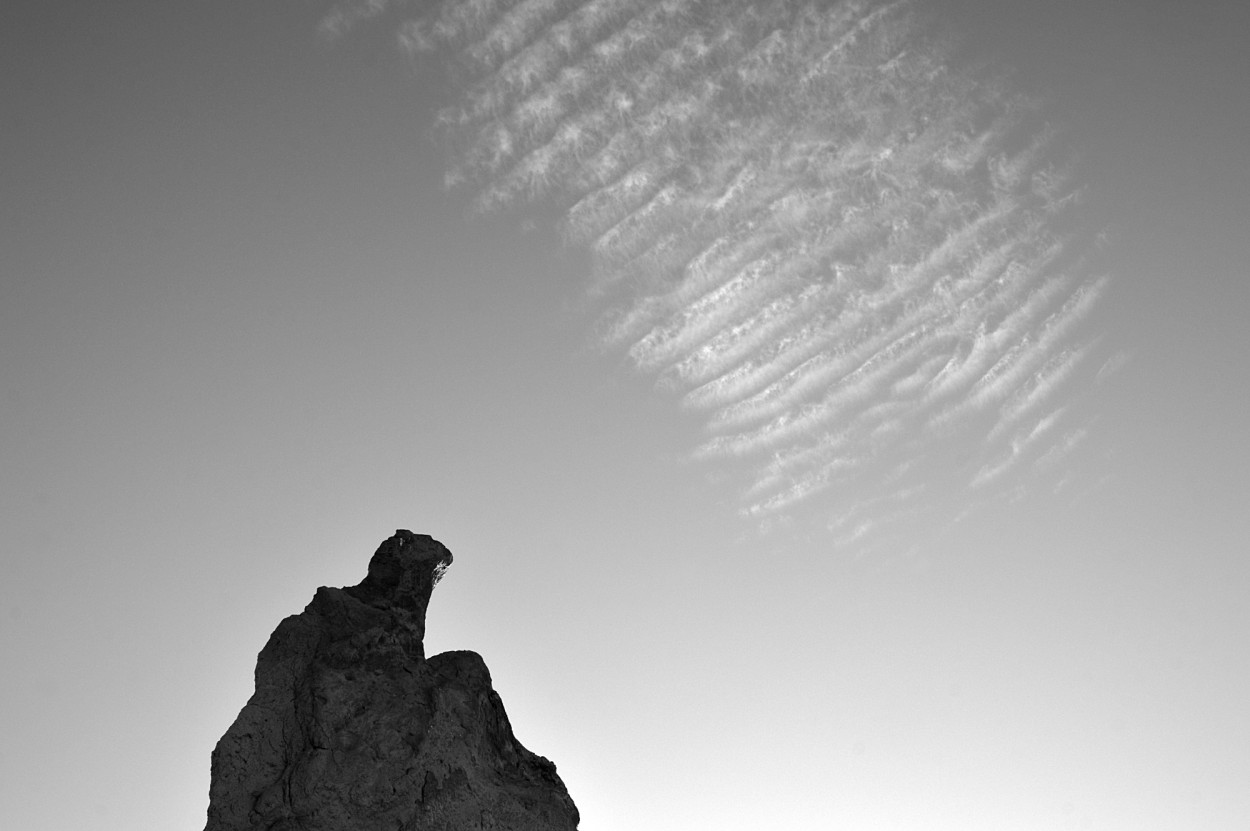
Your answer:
[205,531,578,831]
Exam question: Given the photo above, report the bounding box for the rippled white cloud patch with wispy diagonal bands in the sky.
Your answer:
[324,0,1116,547]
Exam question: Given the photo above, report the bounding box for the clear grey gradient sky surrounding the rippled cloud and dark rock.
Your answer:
[0,0,1250,831]
